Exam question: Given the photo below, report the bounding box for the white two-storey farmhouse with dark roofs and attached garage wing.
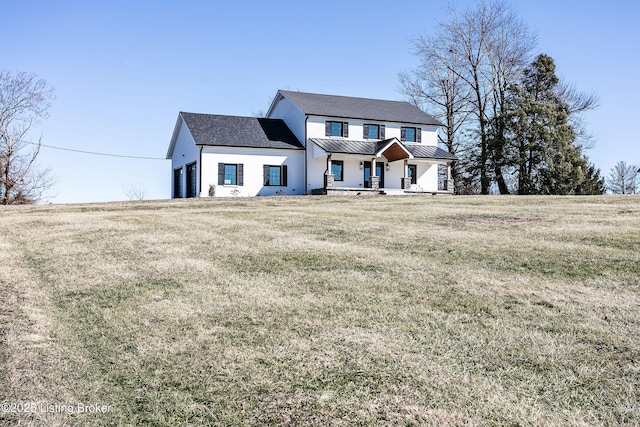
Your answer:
[167,90,455,197]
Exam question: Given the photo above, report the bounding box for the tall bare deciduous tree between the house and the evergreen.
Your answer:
[400,0,536,194]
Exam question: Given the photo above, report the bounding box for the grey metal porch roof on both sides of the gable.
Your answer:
[311,138,457,160]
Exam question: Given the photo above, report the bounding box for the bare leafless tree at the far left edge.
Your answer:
[0,71,53,205]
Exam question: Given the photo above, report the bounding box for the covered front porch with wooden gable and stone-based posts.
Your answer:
[311,138,455,195]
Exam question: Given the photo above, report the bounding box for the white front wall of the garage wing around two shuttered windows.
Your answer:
[200,147,304,197]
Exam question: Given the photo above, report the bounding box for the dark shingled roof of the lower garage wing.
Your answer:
[180,112,304,150]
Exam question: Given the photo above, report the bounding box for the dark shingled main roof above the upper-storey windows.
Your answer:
[280,90,442,126]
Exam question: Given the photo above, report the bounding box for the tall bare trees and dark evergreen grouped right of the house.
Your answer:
[399,0,605,194]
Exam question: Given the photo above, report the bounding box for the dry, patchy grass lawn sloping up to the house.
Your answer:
[0,197,640,426]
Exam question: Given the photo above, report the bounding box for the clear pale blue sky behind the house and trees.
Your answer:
[0,0,640,203]
